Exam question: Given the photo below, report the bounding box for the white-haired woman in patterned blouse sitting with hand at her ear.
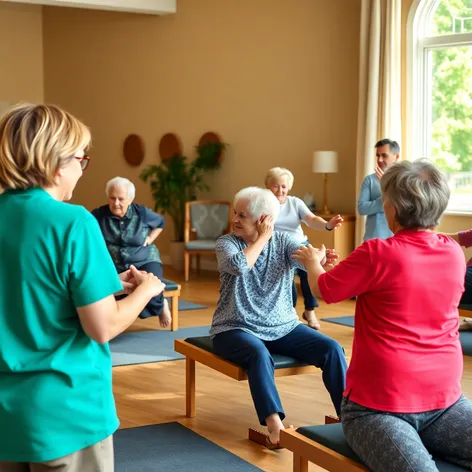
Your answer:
[210,187,347,444]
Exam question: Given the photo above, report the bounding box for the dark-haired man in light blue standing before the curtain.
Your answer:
[357,139,400,241]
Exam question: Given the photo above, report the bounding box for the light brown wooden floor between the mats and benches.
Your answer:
[113,267,472,472]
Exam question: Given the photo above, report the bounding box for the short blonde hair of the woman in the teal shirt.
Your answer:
[0,103,91,189]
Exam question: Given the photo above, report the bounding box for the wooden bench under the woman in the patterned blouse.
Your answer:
[174,336,320,418]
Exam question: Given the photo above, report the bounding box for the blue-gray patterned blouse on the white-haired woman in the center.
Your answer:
[210,231,305,341]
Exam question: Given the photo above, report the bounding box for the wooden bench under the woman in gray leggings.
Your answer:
[280,417,467,472]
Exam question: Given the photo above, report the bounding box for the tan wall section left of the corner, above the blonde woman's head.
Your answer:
[0,2,43,106]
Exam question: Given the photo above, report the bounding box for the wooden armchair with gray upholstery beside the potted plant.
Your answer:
[184,200,232,282]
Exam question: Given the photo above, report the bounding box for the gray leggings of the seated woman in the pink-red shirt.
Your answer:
[341,395,472,472]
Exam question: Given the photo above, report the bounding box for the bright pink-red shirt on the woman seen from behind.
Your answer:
[318,230,465,413]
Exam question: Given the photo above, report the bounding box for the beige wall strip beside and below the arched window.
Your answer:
[402,0,472,257]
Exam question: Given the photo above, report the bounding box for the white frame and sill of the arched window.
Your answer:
[405,0,472,215]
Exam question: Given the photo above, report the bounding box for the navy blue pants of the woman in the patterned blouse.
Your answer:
[213,324,347,425]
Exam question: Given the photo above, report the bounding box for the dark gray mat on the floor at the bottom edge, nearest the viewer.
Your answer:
[113,423,262,472]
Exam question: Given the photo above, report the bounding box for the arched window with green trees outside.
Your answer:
[409,0,472,213]
